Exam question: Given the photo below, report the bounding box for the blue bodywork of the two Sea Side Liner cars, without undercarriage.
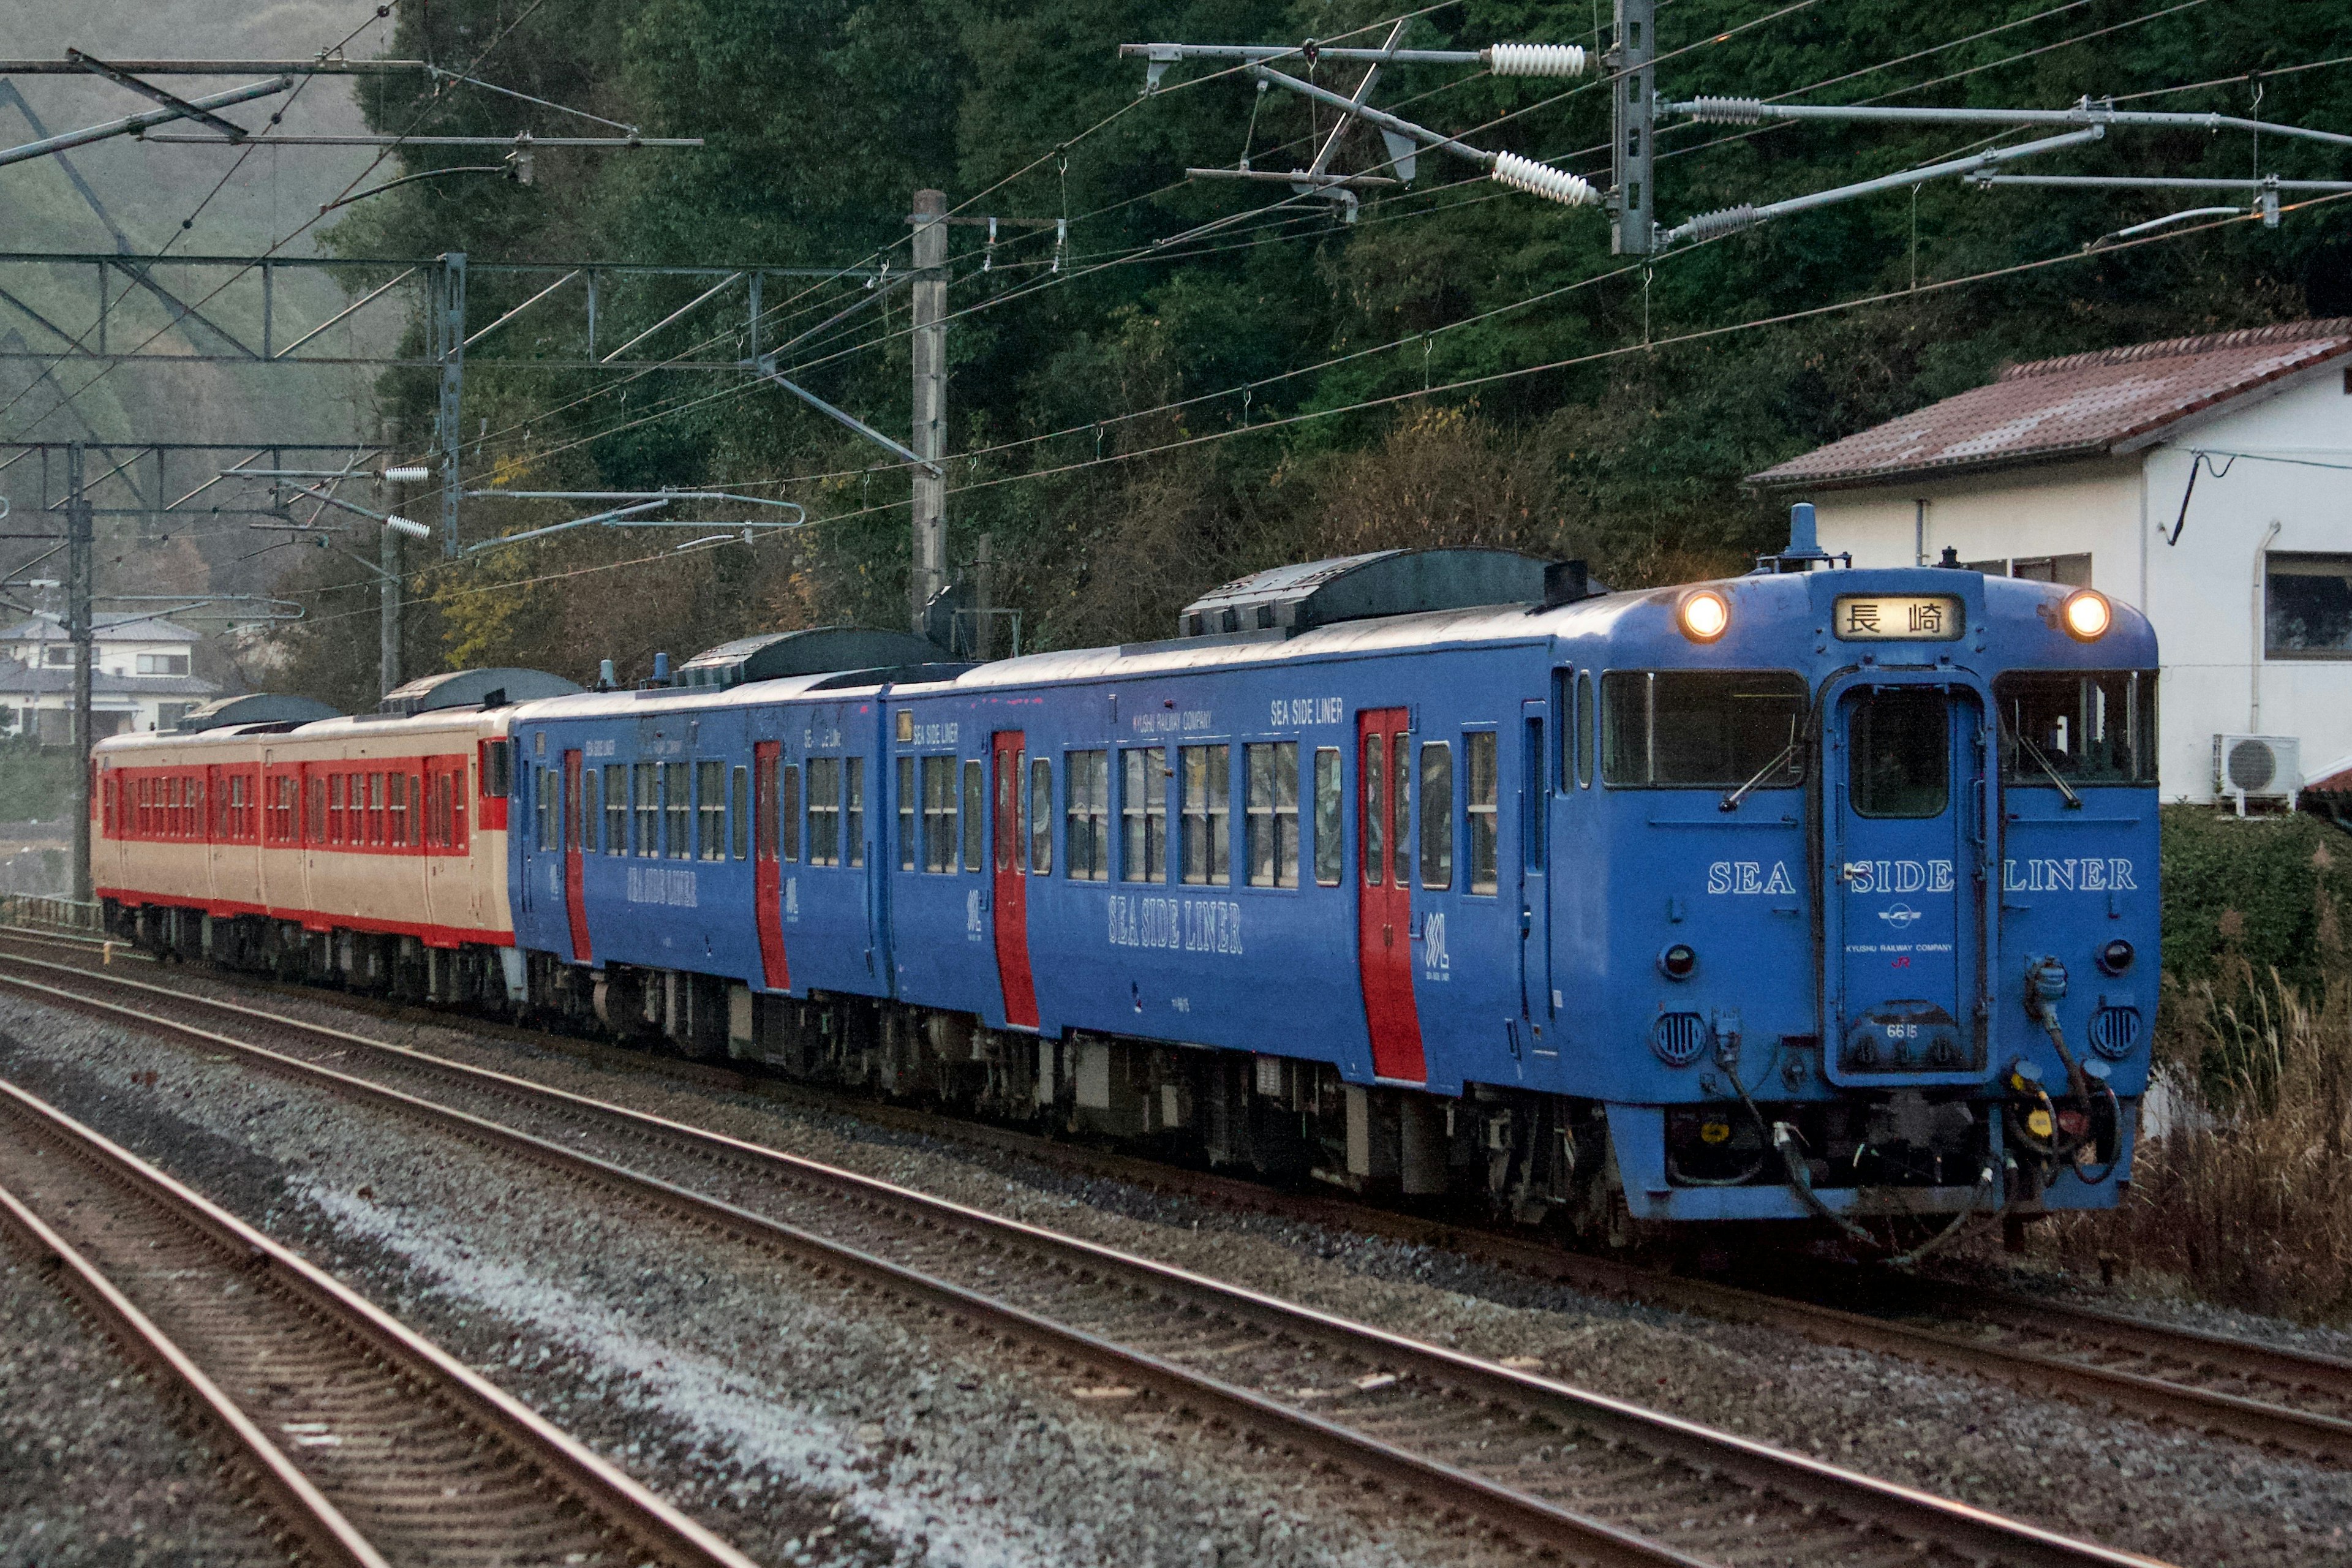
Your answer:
[510,557,2157,1220]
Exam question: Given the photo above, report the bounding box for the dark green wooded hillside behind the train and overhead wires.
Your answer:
[289,0,2352,675]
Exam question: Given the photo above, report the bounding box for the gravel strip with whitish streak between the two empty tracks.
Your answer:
[0,999,1489,1568]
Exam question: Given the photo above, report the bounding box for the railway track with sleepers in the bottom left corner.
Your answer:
[0,1062,750,1568]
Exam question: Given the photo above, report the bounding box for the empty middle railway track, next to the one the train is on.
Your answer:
[0,957,2150,1568]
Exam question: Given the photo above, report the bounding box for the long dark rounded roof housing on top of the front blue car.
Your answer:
[1176,550,1543,637]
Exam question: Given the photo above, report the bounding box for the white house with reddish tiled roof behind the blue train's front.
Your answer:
[1750,317,2352,802]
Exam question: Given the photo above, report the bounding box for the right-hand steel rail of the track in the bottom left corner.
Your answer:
[0,1072,755,1568]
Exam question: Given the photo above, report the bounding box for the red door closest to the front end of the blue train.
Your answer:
[1355,707,1428,1084]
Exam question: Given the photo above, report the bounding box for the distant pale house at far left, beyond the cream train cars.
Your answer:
[0,611,221,745]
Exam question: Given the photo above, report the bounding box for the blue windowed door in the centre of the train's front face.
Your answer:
[1825,687,1988,1084]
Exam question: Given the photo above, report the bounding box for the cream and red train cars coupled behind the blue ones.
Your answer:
[92,670,579,1001]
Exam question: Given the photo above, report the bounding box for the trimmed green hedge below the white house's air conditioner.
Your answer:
[2162,806,2352,992]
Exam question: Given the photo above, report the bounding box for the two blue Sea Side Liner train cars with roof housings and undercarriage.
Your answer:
[513,522,2157,1239]
